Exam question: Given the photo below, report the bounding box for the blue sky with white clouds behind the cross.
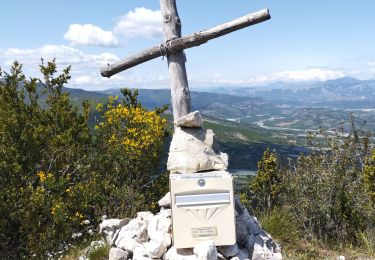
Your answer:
[0,0,375,90]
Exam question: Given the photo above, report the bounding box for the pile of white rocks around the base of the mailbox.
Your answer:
[100,193,282,260]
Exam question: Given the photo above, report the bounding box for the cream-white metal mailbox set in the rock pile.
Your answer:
[170,171,236,248]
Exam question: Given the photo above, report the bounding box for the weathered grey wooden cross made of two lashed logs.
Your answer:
[100,0,271,121]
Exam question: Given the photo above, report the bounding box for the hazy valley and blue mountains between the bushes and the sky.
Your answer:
[65,78,375,175]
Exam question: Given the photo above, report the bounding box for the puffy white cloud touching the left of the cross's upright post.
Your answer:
[114,7,163,38]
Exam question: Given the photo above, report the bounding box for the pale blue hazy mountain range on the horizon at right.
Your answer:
[211,77,375,108]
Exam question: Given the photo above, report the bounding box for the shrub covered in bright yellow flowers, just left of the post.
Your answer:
[95,89,167,189]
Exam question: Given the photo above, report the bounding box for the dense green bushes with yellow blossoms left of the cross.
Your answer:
[0,61,165,259]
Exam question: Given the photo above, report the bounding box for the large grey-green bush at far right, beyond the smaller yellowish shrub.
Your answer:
[283,128,373,243]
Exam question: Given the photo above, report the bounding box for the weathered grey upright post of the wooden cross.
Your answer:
[159,0,191,121]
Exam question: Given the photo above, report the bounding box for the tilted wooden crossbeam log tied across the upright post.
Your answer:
[100,9,271,77]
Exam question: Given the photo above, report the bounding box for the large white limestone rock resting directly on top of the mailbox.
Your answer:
[167,127,228,173]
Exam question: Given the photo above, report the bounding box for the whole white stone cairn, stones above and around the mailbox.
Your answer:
[100,112,282,260]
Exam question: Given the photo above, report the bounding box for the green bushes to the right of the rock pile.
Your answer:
[250,121,375,245]
